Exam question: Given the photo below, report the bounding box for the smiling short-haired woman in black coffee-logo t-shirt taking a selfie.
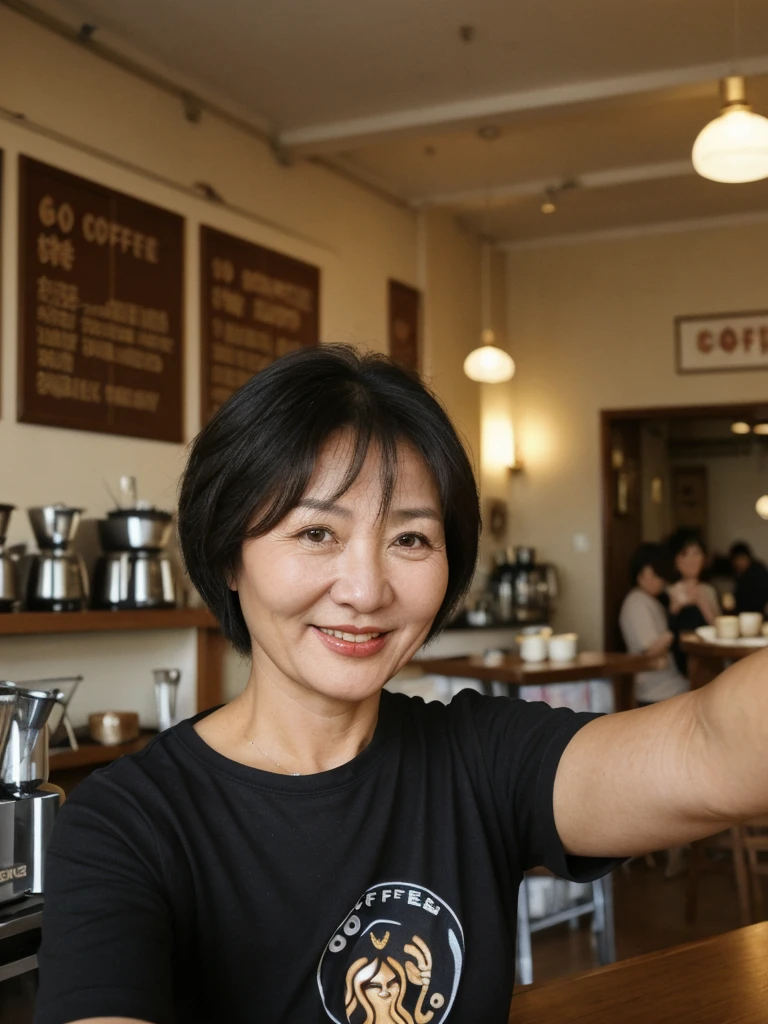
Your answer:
[36,348,768,1024]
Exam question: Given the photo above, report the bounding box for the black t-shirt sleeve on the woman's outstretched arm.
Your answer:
[465,690,621,882]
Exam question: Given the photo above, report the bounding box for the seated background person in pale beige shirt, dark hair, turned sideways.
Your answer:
[618,544,688,706]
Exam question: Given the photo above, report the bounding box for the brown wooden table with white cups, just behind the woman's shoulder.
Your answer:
[412,651,659,711]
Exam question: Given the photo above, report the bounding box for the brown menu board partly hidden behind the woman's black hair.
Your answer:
[200,227,319,423]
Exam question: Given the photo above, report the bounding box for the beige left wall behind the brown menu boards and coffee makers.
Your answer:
[0,7,479,718]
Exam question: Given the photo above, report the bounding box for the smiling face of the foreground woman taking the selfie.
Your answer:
[232,435,449,701]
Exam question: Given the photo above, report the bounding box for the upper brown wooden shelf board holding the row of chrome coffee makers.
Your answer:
[0,608,217,636]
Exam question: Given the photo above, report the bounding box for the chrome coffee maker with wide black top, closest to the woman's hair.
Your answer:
[91,502,177,609]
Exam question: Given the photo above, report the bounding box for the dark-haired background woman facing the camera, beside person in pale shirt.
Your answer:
[667,527,720,675]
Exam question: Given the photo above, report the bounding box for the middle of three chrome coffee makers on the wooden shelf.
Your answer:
[26,503,88,611]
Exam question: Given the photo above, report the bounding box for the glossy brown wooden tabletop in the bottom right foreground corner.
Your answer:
[509,922,768,1024]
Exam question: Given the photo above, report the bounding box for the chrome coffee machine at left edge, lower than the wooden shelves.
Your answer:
[0,682,65,906]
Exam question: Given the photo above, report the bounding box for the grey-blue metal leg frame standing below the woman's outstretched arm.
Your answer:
[517,867,616,985]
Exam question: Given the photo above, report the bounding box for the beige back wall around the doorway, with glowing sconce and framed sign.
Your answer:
[508,223,768,645]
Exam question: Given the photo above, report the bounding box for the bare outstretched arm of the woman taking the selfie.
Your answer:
[554,651,768,857]
